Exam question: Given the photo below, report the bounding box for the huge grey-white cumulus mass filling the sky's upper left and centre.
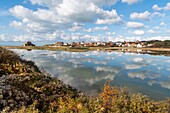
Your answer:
[9,0,122,39]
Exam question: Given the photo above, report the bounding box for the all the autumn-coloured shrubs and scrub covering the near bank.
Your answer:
[0,47,170,113]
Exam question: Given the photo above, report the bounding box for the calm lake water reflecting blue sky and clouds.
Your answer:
[13,49,170,100]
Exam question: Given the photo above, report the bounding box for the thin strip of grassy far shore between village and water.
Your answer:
[3,46,170,56]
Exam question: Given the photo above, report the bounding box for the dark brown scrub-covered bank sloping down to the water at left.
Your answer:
[0,48,79,112]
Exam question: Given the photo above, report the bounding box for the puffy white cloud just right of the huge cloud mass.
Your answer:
[130,11,151,20]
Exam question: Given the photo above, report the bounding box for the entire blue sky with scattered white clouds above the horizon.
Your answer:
[0,0,170,42]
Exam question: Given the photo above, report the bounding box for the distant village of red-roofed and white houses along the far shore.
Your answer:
[45,40,170,48]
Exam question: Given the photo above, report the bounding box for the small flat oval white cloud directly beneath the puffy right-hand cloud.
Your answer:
[126,22,146,29]
